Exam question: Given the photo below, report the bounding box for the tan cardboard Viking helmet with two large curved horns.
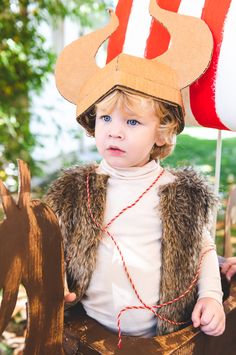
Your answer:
[55,0,213,131]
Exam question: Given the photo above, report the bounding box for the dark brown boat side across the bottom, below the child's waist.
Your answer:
[64,286,236,355]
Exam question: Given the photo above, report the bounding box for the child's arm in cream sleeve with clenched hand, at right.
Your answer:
[192,231,225,336]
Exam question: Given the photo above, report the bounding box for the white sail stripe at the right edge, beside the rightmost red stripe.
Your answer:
[215,0,236,130]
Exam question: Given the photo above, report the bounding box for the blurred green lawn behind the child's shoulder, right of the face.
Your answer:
[163,134,236,192]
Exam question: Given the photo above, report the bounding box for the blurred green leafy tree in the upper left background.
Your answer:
[0,0,109,189]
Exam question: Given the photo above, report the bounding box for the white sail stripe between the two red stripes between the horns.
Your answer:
[123,0,152,57]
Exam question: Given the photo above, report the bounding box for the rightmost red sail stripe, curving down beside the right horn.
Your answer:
[190,0,231,130]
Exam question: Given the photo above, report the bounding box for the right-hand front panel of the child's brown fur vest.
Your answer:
[157,168,217,335]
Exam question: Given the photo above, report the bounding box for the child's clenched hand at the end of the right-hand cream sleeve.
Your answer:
[192,297,225,336]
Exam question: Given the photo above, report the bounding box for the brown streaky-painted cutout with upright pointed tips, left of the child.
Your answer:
[0,161,64,355]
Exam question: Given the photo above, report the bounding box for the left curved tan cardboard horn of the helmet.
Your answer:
[55,9,119,104]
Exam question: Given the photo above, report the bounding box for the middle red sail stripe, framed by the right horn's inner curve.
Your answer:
[145,0,181,59]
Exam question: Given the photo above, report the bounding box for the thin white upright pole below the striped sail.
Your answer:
[212,130,222,239]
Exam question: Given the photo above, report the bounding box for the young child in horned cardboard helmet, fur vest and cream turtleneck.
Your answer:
[47,0,225,344]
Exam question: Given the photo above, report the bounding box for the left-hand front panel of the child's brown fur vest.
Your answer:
[46,166,108,300]
